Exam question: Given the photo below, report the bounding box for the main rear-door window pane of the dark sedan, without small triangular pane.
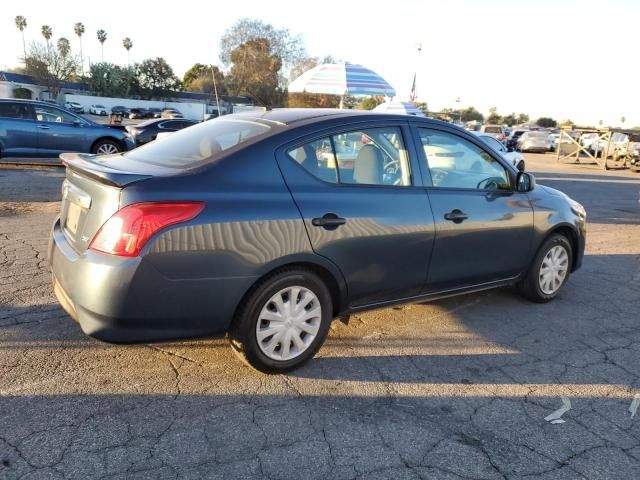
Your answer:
[332,127,411,186]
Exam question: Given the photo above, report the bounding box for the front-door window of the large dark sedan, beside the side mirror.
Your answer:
[418,128,510,190]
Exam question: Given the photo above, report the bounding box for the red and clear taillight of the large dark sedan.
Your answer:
[89,202,204,257]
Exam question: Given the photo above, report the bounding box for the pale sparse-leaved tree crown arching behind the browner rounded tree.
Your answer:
[220,18,307,76]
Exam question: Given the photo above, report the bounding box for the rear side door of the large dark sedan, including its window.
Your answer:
[277,123,434,307]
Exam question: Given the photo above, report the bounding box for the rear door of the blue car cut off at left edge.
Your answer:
[0,102,38,155]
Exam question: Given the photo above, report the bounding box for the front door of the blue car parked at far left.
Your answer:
[35,105,91,155]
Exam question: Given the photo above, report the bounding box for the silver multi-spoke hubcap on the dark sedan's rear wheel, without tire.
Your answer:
[256,286,322,361]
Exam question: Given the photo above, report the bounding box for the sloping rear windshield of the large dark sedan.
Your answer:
[124,118,272,169]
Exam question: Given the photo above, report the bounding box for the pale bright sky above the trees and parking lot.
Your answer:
[0,0,640,127]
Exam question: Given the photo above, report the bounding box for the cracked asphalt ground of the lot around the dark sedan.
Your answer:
[0,155,640,480]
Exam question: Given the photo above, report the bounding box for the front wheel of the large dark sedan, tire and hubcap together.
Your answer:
[517,234,573,303]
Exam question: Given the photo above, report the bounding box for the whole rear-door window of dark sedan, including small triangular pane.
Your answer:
[287,127,411,186]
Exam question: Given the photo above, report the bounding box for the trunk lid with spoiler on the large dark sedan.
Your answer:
[60,153,175,253]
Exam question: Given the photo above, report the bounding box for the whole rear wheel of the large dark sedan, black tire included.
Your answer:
[229,268,333,373]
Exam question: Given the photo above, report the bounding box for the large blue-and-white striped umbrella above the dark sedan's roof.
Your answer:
[289,62,396,105]
